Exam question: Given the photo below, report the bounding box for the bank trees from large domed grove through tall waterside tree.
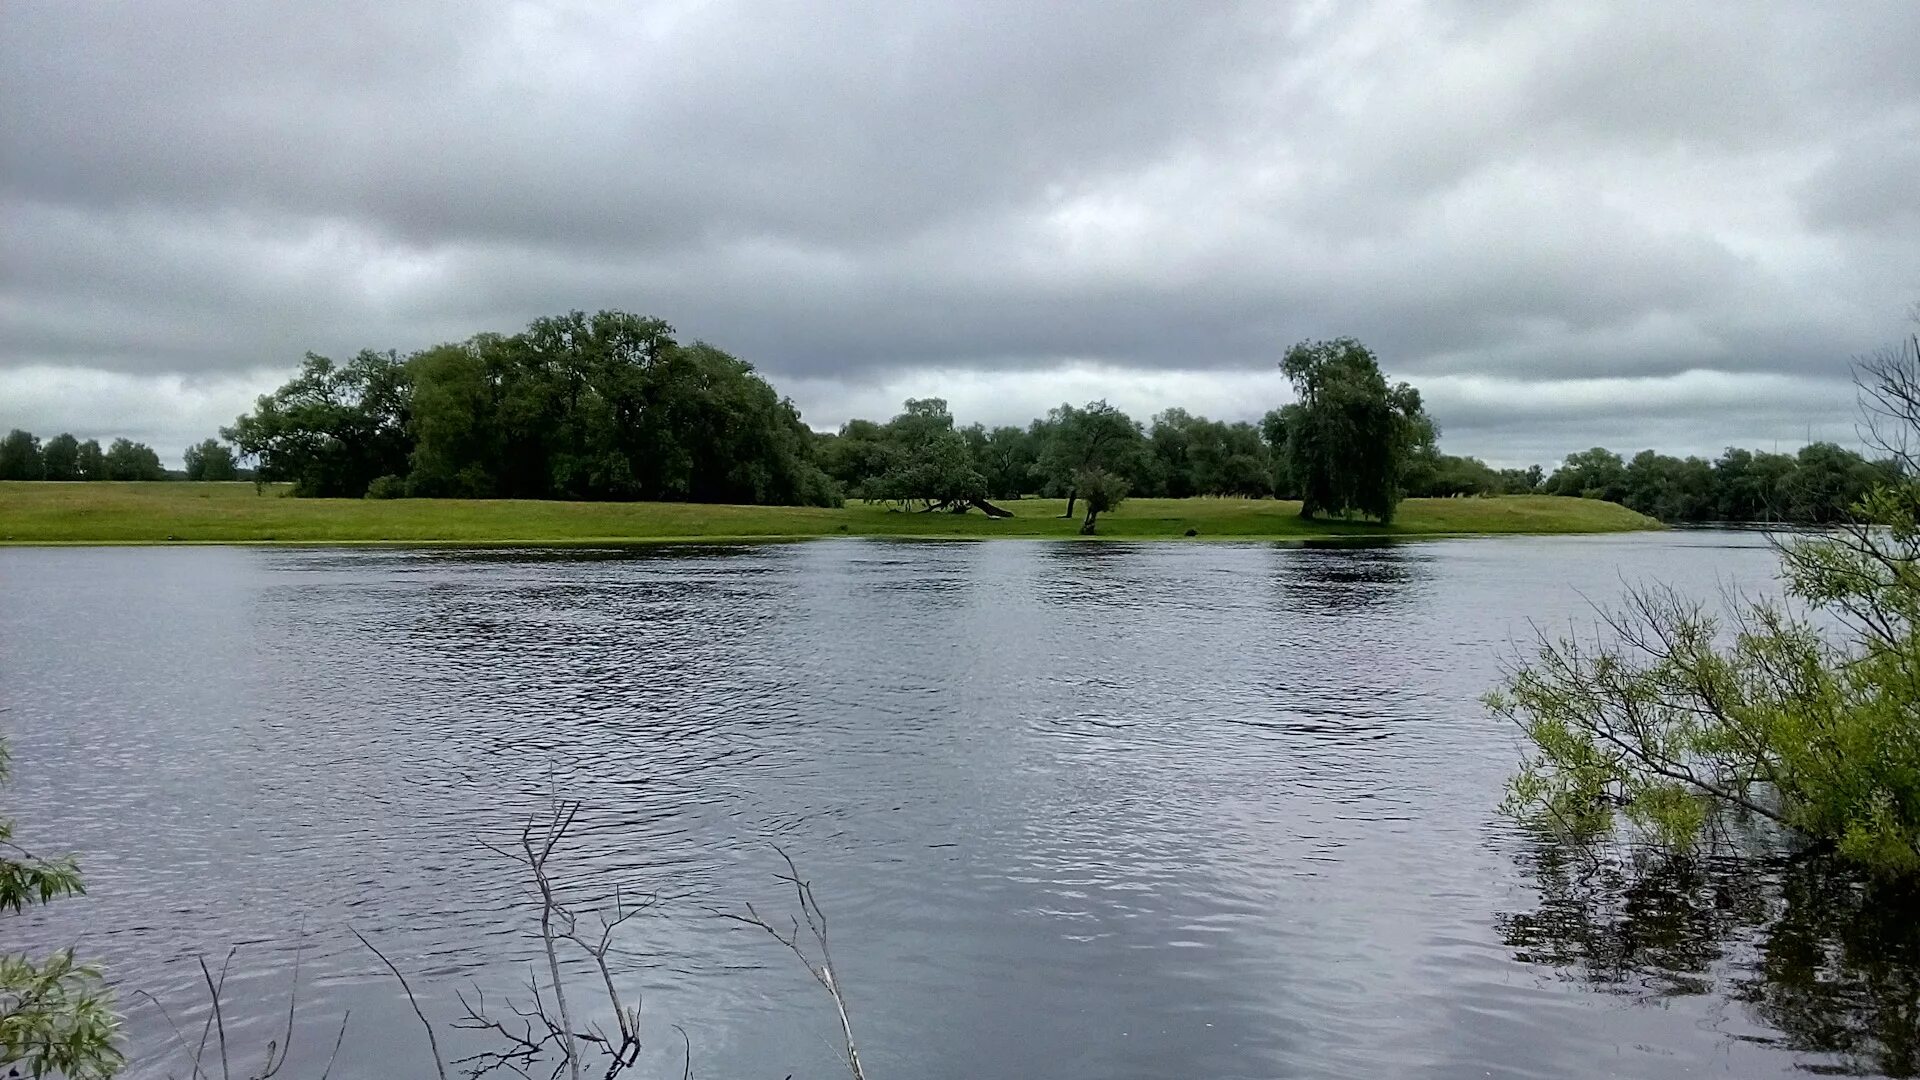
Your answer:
[202,311,1434,521]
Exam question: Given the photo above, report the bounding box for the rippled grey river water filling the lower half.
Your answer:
[0,532,1920,1080]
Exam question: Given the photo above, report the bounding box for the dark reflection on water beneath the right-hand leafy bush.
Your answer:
[1496,844,1920,1076]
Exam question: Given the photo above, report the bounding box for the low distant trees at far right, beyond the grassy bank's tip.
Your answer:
[1540,442,1899,525]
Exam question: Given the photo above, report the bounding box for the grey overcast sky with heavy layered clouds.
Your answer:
[0,0,1920,463]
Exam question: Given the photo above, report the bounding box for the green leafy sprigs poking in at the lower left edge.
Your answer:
[0,742,125,1080]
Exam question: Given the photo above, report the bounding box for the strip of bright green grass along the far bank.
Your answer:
[0,482,1659,544]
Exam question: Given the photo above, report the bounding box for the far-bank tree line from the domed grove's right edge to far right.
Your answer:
[820,342,1899,525]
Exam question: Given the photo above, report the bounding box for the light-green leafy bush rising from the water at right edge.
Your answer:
[1488,317,1920,874]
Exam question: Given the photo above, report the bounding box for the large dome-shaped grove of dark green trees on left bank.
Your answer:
[221,311,839,505]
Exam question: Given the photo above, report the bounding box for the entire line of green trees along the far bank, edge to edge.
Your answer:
[0,311,1891,523]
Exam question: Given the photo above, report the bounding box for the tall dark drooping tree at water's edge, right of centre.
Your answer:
[1269,338,1432,523]
